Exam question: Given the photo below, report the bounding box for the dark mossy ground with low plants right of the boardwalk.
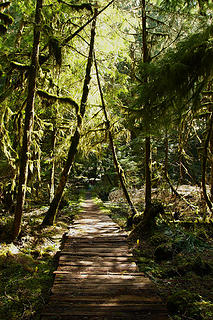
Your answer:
[101,189,213,320]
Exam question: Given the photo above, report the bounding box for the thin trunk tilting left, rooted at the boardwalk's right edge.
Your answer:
[94,54,137,222]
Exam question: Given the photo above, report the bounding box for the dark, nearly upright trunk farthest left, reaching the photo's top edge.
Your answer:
[12,0,43,239]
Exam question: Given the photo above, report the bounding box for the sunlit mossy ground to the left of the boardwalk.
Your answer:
[0,189,83,320]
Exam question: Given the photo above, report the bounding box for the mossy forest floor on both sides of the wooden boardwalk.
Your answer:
[0,186,213,320]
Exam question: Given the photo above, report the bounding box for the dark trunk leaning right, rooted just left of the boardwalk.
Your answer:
[42,11,97,226]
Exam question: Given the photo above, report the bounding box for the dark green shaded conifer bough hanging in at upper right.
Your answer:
[135,26,213,129]
